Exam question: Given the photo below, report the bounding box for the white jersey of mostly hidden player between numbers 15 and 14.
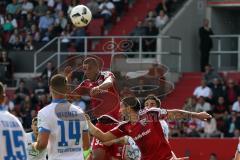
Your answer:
[27,132,47,160]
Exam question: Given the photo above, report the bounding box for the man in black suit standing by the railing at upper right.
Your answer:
[199,19,213,72]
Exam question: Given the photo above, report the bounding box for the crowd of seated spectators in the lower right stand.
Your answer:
[169,65,240,137]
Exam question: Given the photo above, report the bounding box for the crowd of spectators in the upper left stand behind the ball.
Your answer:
[0,0,133,51]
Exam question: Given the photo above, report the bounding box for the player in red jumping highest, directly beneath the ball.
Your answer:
[65,57,122,160]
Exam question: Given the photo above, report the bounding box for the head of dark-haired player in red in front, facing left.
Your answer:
[120,97,141,117]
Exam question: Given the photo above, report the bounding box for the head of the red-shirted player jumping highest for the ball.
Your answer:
[83,57,99,80]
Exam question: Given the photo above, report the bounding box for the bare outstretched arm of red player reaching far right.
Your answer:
[167,109,212,121]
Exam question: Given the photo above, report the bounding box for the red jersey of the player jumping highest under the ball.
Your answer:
[74,71,120,119]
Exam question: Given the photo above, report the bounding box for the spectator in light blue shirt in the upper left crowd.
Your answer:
[38,10,54,35]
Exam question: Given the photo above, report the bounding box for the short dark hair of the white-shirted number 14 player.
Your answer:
[50,74,67,93]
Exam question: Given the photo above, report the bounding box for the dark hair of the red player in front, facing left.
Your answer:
[122,97,141,112]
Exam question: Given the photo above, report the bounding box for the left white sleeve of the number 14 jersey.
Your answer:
[38,112,51,133]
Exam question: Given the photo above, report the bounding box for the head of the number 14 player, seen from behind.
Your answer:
[50,74,68,98]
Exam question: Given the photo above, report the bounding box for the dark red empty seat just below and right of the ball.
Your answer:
[87,18,104,36]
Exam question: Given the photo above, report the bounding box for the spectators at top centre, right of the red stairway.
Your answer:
[130,0,185,52]
